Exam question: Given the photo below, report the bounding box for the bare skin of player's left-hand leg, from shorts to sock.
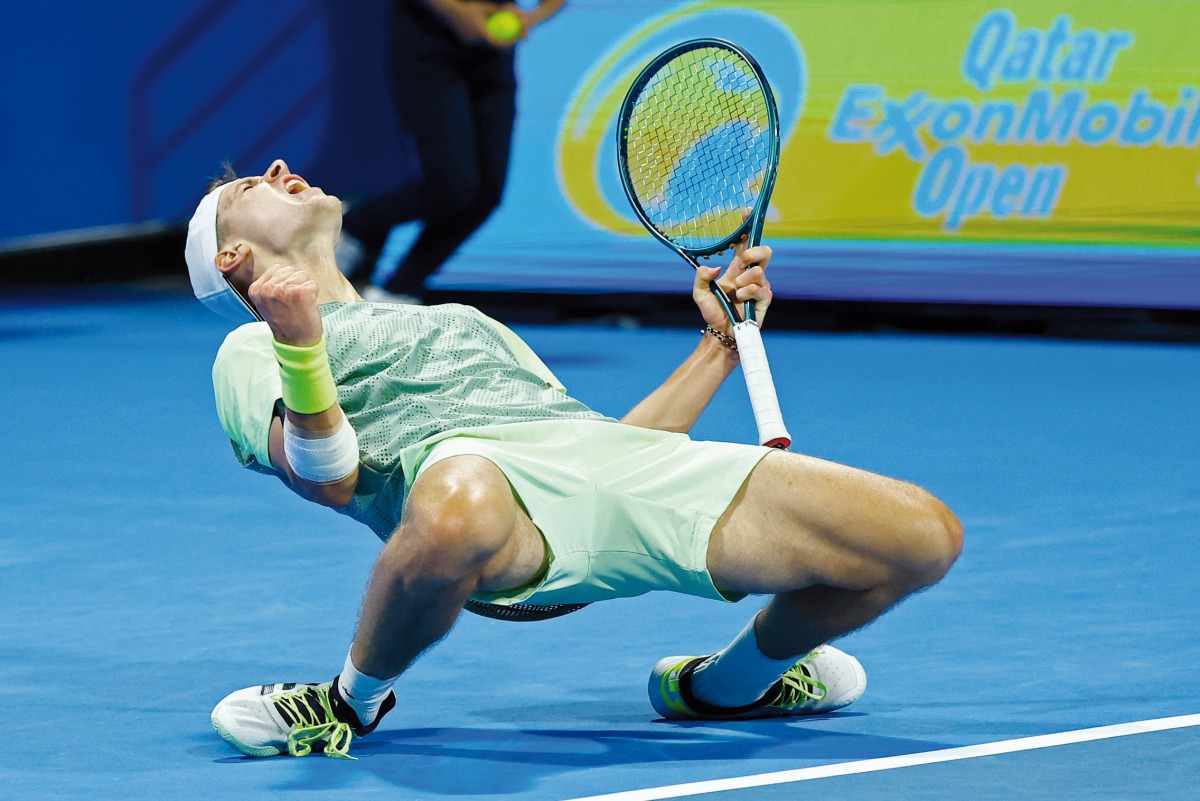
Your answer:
[350,456,545,679]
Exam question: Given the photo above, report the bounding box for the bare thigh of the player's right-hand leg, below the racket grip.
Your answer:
[708,452,936,594]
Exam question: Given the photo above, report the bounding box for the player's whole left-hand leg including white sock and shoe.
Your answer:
[212,456,545,757]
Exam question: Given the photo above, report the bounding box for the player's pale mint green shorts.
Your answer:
[401,420,770,604]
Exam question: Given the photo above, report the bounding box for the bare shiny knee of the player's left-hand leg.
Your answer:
[388,456,517,579]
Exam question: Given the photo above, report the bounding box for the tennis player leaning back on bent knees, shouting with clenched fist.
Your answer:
[186,161,962,757]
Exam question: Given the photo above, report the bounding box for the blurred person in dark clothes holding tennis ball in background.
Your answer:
[342,0,564,303]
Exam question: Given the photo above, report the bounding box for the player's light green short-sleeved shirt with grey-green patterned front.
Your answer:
[212,302,611,538]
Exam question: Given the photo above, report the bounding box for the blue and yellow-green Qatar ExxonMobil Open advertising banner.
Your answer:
[440,0,1200,307]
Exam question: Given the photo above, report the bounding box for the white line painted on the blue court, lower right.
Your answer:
[559,715,1200,801]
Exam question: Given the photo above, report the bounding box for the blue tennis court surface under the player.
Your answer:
[0,289,1200,801]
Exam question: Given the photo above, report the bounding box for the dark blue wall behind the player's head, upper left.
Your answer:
[0,0,404,242]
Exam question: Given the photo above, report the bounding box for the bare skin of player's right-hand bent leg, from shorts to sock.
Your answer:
[708,453,962,660]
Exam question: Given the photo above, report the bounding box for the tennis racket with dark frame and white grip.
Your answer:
[617,38,792,448]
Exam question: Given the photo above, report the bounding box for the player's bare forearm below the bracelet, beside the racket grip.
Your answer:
[622,336,738,433]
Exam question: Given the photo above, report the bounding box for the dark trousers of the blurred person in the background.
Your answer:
[343,4,516,296]
